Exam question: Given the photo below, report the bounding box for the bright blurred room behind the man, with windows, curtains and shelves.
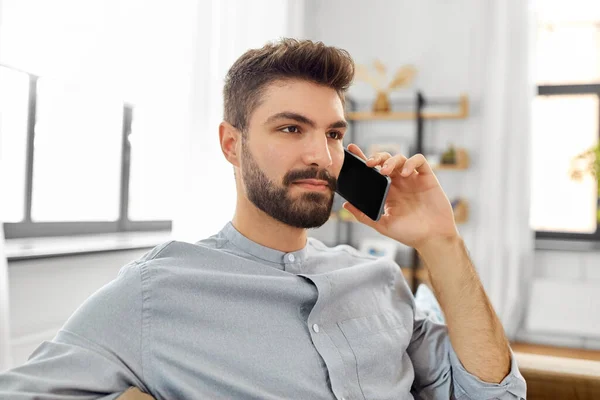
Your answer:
[0,0,600,394]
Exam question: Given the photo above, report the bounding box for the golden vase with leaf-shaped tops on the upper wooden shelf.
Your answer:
[355,60,417,113]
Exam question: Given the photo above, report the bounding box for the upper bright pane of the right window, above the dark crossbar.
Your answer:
[537,22,600,85]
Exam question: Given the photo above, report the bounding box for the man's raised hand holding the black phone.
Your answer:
[344,144,458,250]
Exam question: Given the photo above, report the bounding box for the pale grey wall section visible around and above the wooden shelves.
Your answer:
[305,0,480,265]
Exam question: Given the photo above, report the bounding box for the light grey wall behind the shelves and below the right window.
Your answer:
[305,0,600,348]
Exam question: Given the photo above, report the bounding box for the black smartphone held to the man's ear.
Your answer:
[336,149,392,221]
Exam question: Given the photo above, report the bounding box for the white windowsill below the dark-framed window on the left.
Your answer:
[6,231,172,262]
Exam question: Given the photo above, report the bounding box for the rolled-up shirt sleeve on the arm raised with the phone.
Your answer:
[407,309,527,400]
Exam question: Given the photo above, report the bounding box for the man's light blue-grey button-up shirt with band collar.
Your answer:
[0,223,526,400]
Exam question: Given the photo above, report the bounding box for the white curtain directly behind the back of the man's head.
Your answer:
[173,0,304,242]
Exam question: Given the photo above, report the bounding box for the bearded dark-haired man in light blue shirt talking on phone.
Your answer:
[0,39,525,399]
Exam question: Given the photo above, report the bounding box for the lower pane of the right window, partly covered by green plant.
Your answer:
[531,95,599,233]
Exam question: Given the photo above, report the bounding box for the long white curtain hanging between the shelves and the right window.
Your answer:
[470,0,535,339]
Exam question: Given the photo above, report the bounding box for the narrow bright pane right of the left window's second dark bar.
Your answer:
[129,107,174,221]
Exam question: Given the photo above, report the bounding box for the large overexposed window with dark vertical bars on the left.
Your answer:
[0,0,195,238]
